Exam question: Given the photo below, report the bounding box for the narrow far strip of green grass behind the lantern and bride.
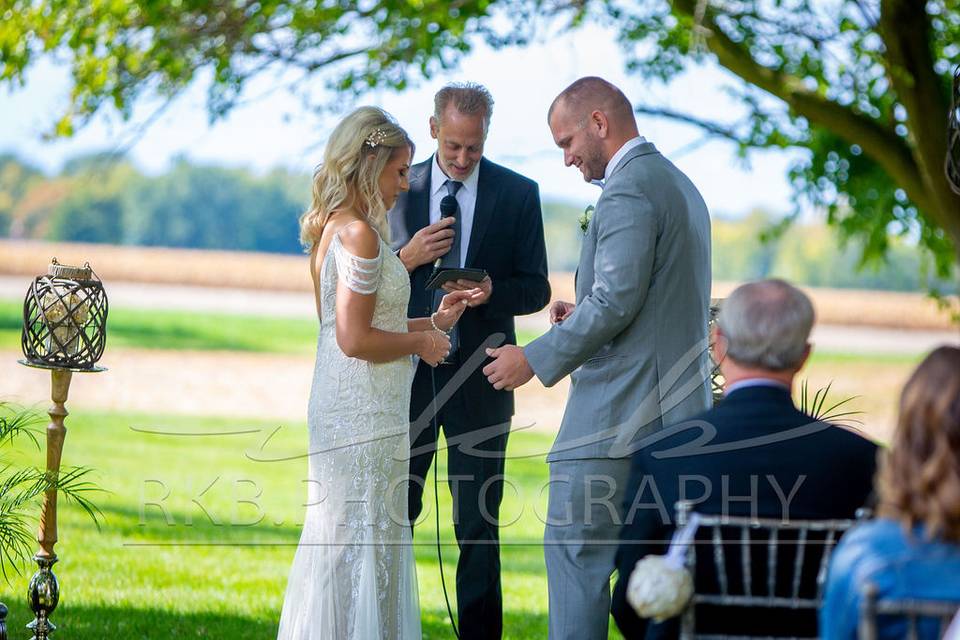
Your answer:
[0,300,537,354]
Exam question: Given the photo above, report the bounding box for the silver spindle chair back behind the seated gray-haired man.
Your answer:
[676,501,860,640]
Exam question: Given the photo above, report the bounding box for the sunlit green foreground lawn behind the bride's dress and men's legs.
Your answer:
[0,412,620,640]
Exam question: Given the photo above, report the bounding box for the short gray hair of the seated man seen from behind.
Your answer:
[717,279,814,371]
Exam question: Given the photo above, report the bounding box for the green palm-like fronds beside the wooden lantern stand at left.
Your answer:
[0,402,103,583]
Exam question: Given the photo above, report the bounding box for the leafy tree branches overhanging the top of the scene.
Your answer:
[0,0,960,288]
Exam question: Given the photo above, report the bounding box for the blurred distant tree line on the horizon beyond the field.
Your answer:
[0,155,957,293]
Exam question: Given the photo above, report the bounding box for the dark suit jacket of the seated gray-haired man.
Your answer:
[612,386,877,639]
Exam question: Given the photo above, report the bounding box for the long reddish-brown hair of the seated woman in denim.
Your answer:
[879,347,960,543]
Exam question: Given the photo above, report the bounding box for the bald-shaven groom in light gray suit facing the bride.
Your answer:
[484,77,710,640]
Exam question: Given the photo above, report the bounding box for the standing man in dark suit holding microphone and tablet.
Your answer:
[389,83,550,639]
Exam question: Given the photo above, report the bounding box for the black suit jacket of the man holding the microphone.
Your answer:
[388,156,550,427]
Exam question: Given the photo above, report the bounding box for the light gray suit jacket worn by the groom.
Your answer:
[524,143,710,462]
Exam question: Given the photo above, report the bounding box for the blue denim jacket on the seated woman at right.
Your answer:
[820,518,960,640]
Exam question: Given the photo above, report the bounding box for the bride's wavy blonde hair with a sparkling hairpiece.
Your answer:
[300,107,413,251]
